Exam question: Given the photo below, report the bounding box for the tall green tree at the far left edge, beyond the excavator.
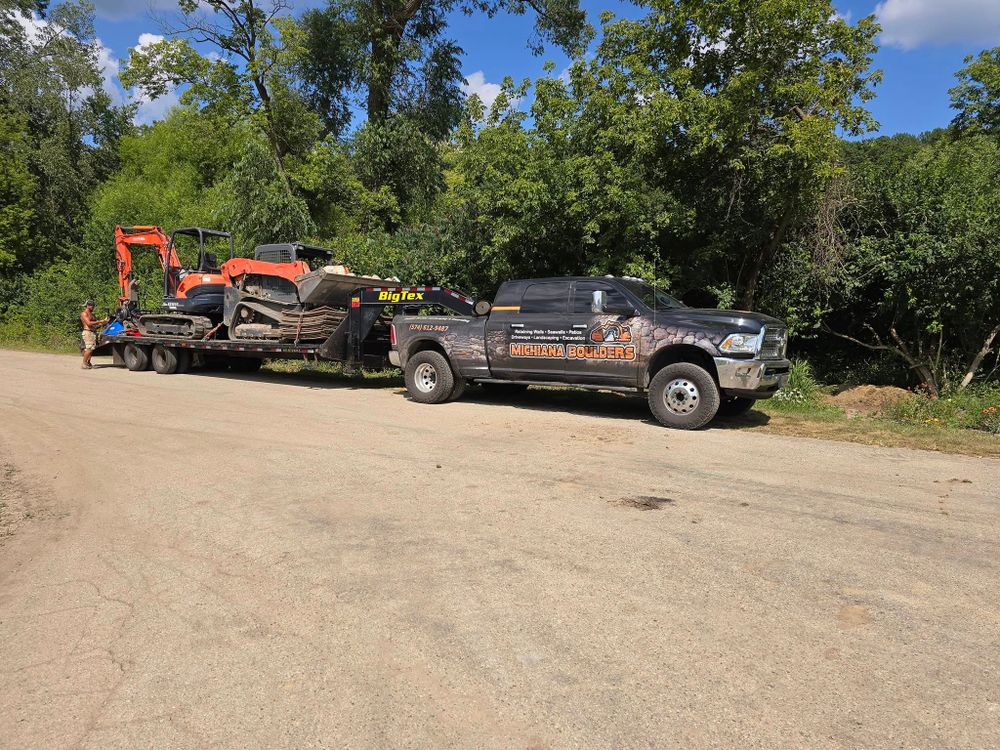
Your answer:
[0,2,131,272]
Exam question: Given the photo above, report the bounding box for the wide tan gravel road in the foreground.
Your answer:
[0,351,1000,750]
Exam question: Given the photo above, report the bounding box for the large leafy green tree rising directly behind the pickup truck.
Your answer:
[450,0,879,307]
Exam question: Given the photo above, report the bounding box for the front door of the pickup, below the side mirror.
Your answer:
[566,279,641,386]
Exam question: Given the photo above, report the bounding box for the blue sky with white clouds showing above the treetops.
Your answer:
[76,0,1000,135]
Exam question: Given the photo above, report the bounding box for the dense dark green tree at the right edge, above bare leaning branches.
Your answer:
[826,134,1000,391]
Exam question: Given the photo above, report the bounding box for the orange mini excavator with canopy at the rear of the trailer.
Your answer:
[115,226,233,338]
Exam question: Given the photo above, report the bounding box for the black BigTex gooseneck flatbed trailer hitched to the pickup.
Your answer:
[99,286,490,375]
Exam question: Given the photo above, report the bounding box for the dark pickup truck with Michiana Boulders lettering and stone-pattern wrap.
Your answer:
[389,277,789,429]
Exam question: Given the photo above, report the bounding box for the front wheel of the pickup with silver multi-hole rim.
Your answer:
[649,362,720,430]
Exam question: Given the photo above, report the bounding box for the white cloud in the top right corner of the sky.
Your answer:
[875,0,1000,49]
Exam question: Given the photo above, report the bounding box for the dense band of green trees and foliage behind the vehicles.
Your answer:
[0,0,1000,390]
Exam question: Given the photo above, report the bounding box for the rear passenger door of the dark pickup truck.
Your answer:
[486,280,572,380]
